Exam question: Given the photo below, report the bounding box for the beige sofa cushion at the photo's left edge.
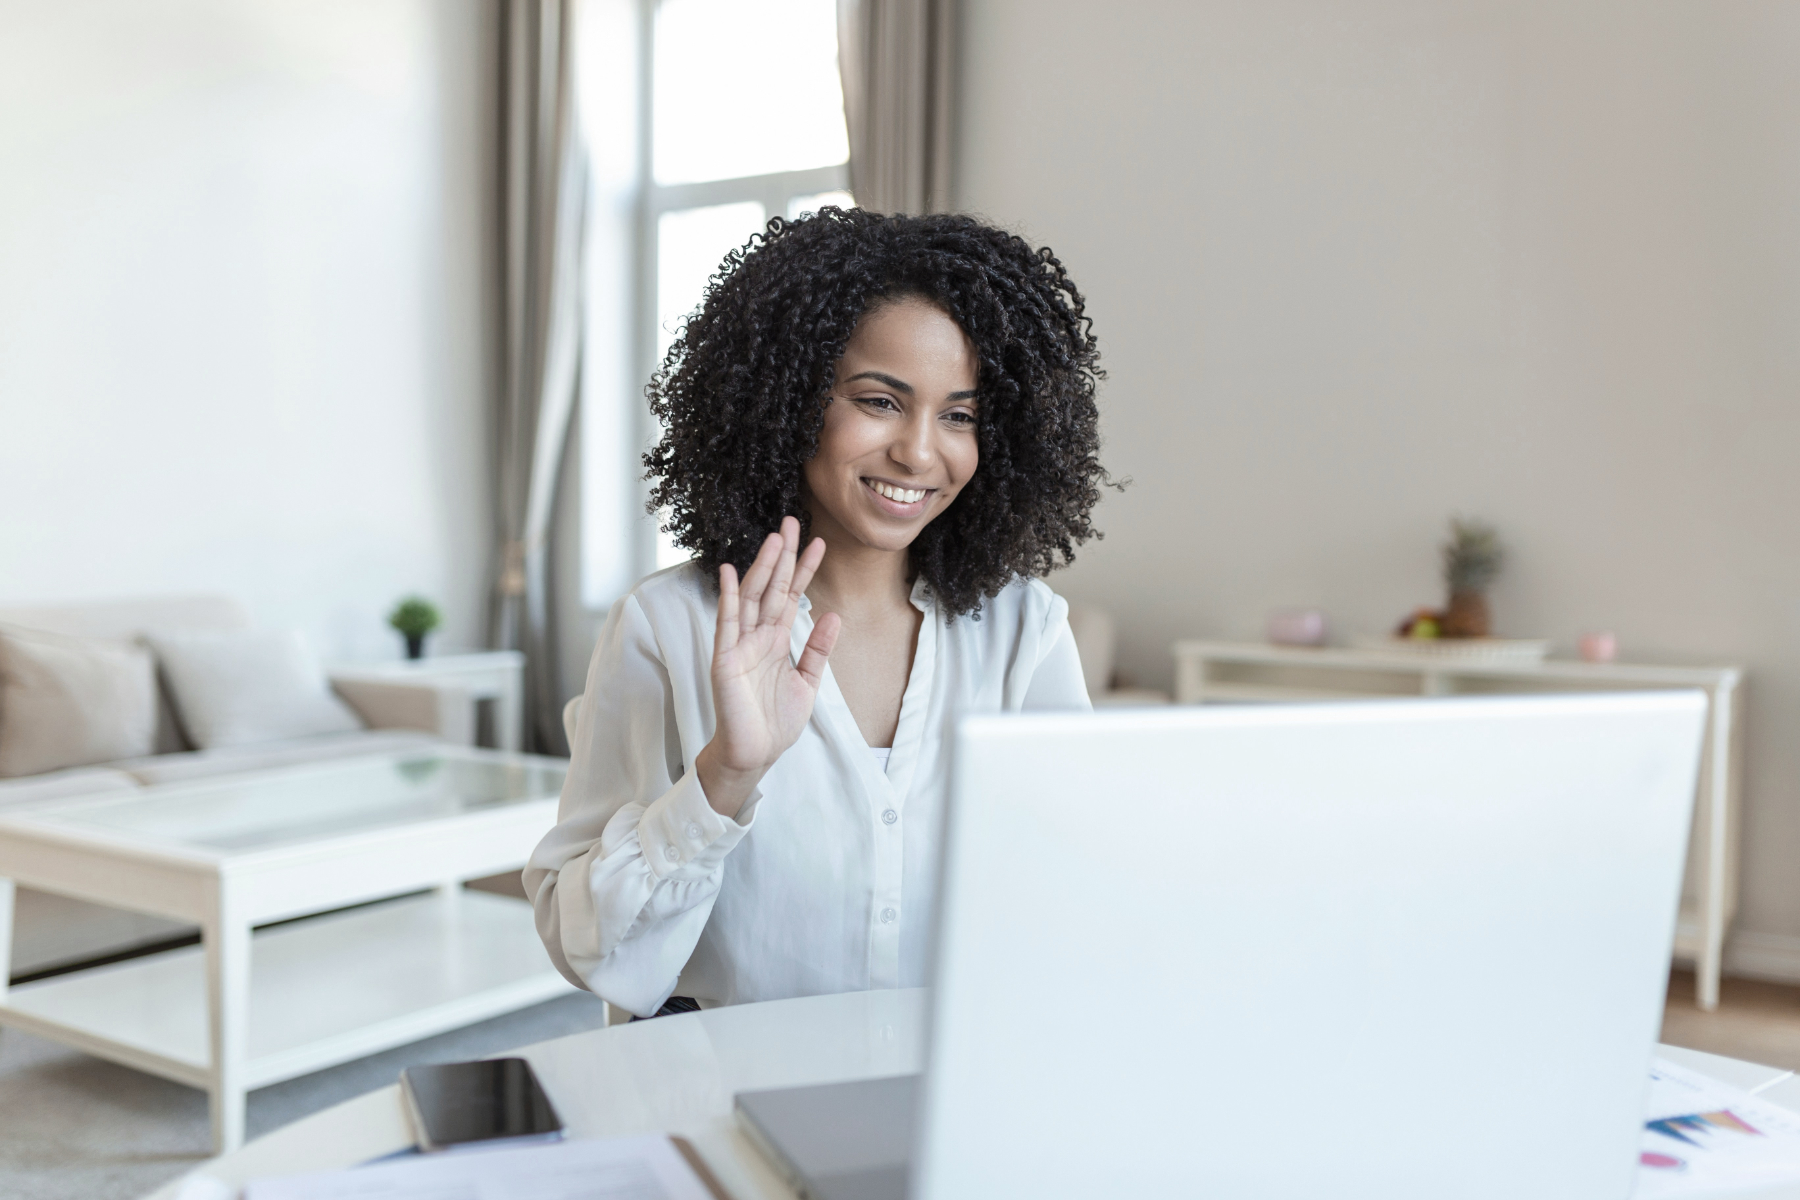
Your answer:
[0,624,157,777]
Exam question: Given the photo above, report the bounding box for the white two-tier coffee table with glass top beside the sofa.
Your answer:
[0,747,571,1151]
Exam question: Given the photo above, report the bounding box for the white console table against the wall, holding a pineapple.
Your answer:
[1174,640,1744,1011]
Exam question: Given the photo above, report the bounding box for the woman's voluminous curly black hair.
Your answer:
[644,207,1111,615]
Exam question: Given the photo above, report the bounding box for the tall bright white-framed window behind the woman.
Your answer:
[581,0,853,606]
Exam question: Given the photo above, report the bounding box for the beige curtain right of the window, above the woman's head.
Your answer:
[837,0,956,214]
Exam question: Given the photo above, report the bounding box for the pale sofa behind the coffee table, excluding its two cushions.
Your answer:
[0,596,473,977]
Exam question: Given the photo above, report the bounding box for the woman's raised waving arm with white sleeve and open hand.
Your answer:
[524,518,837,1016]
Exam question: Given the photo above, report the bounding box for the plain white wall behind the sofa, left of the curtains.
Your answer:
[0,0,493,657]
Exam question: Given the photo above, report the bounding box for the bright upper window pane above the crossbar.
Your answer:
[653,0,850,184]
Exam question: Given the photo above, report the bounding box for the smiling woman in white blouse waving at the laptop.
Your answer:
[526,209,1105,1016]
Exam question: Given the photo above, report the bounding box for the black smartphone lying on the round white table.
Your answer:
[400,1058,563,1150]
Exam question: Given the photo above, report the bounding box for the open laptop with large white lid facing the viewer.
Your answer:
[740,693,1705,1200]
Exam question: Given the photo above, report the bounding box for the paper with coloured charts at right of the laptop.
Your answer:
[1633,1058,1800,1200]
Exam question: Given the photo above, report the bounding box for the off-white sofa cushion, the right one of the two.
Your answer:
[146,630,362,757]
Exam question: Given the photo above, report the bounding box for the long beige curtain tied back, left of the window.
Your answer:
[488,0,587,752]
